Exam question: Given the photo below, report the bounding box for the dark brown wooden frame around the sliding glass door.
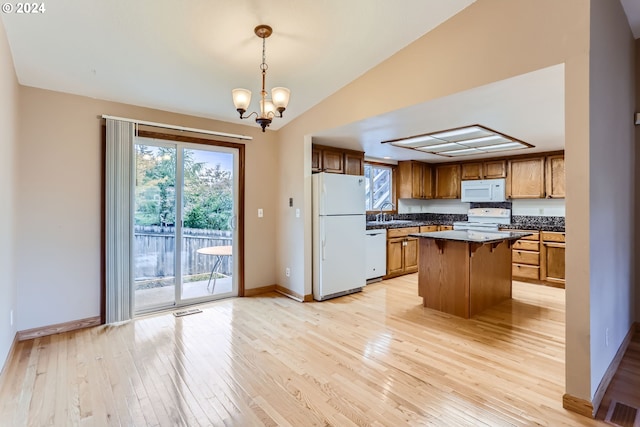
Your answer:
[100,126,246,324]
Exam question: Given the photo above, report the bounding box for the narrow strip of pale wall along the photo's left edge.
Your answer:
[0,15,18,364]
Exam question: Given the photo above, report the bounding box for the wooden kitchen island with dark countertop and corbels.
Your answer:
[410,230,529,319]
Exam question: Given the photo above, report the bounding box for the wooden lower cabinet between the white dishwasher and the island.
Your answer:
[385,227,420,278]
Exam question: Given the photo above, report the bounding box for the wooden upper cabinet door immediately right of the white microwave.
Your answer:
[507,157,545,199]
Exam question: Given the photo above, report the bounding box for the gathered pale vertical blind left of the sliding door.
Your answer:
[105,119,136,323]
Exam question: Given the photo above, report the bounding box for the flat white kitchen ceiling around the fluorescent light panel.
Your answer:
[314,64,564,163]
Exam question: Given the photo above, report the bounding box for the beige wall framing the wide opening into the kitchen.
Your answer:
[277,0,592,399]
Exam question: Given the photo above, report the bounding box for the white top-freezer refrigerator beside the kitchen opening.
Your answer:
[311,172,366,301]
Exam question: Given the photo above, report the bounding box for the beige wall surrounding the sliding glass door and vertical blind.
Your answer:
[16,87,278,330]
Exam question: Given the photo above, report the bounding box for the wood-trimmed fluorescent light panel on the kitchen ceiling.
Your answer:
[382,124,533,157]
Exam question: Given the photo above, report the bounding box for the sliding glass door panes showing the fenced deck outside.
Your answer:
[132,138,239,313]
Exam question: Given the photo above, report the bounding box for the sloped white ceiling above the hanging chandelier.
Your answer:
[2,0,475,129]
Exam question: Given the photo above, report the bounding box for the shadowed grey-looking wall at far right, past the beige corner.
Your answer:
[589,0,637,393]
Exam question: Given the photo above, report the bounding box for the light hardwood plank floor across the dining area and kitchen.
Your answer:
[0,274,605,427]
